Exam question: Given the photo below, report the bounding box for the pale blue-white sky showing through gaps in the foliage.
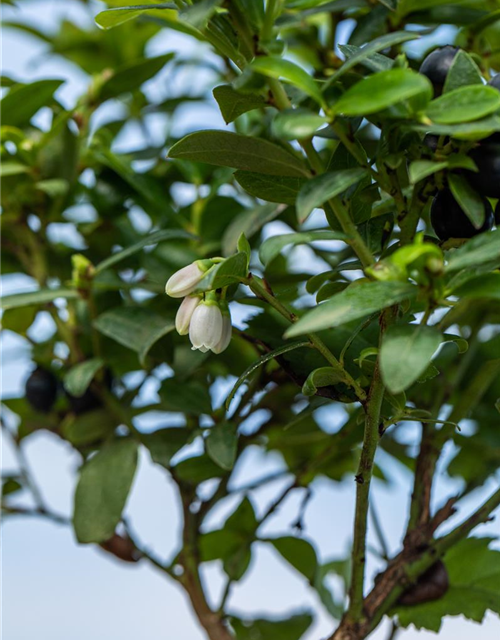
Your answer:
[0,0,500,640]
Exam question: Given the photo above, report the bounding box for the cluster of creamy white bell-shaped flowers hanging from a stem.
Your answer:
[165,260,232,353]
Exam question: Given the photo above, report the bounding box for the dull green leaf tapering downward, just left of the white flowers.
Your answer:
[93,307,175,367]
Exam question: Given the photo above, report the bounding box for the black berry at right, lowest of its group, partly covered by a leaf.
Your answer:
[431,189,493,240]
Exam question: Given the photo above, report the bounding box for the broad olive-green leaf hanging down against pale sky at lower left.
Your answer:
[73,438,138,543]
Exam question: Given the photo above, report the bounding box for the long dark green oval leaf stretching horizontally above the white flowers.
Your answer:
[169,131,307,176]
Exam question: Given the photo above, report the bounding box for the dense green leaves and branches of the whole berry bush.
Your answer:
[0,0,500,640]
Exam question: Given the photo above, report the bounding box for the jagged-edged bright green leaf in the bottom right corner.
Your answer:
[395,538,500,632]
